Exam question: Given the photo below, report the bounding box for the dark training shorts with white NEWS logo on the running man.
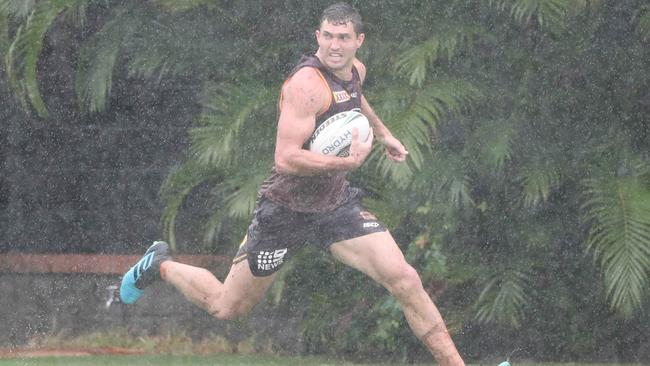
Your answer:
[233,193,386,277]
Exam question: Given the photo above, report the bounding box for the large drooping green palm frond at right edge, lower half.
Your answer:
[583,172,650,316]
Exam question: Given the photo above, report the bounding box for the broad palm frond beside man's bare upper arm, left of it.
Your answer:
[189,82,277,168]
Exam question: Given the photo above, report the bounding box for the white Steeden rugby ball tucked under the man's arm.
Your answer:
[309,110,370,157]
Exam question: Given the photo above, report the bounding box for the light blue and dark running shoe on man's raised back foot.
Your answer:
[120,241,171,304]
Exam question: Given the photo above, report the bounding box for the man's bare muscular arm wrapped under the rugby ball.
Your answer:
[275,67,372,176]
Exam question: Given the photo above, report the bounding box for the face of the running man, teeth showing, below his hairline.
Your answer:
[316,20,364,70]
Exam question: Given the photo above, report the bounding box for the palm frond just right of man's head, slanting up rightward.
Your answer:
[395,24,485,86]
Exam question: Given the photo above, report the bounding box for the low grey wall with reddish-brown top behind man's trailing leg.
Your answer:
[0,254,302,352]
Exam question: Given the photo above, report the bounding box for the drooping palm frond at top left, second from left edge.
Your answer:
[75,4,142,112]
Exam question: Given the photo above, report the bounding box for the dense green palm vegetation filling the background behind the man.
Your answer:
[0,0,650,360]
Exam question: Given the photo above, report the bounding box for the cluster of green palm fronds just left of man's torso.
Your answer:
[163,80,277,252]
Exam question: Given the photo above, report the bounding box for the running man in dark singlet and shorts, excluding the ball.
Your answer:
[120,3,464,366]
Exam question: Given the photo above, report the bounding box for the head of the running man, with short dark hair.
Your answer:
[316,3,365,71]
